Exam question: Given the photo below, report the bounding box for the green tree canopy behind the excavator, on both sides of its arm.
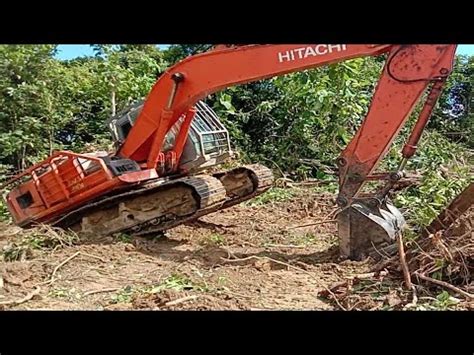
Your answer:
[0,44,474,182]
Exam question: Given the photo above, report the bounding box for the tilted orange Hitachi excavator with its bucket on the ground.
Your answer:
[1,44,456,260]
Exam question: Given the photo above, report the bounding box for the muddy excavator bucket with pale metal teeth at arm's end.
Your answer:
[338,198,405,260]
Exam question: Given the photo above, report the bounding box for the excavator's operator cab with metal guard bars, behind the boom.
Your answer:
[107,100,232,172]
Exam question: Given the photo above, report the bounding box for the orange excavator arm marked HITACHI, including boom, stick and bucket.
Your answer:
[118,44,456,258]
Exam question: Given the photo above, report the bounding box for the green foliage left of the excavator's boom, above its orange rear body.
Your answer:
[0,45,167,170]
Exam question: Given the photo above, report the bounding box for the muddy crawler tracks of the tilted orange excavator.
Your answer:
[54,164,273,235]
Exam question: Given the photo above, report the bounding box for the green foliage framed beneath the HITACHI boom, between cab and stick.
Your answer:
[212,58,381,178]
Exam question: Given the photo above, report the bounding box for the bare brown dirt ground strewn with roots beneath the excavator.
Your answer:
[0,188,466,310]
